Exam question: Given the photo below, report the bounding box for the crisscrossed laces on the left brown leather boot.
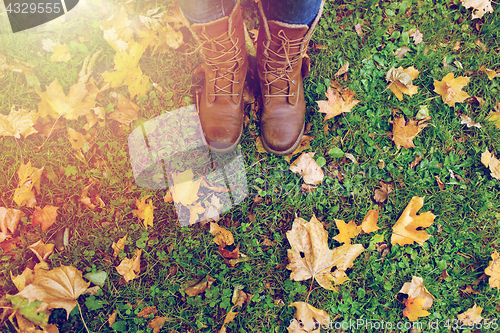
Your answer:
[200,31,243,97]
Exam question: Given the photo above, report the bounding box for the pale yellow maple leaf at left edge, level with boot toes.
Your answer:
[0,105,38,139]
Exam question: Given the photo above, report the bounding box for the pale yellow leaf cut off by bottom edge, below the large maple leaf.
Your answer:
[287,302,330,333]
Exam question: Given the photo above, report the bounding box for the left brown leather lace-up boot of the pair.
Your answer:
[190,3,248,153]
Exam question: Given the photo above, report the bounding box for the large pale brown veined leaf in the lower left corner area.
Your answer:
[16,266,90,318]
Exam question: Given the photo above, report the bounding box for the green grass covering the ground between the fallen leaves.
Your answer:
[0,0,500,332]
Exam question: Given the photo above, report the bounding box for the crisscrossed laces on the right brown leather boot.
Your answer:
[262,30,303,97]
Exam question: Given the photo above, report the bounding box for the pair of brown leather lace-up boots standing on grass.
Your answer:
[185,2,323,155]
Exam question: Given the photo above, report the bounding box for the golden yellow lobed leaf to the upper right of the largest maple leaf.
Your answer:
[391,197,436,246]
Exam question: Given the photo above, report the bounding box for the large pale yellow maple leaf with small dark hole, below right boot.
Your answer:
[286,216,364,290]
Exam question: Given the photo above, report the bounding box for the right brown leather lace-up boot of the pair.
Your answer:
[257,3,323,155]
